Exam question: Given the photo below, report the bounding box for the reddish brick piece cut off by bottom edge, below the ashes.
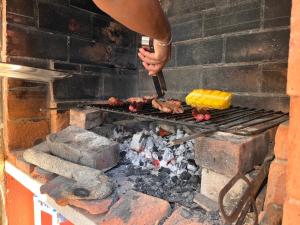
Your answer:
[163,207,204,225]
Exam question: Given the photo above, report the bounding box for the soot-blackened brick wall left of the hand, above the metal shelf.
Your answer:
[3,0,137,99]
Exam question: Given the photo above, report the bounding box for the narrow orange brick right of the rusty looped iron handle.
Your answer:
[265,160,287,208]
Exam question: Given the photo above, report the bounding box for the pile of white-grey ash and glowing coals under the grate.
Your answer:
[107,124,201,209]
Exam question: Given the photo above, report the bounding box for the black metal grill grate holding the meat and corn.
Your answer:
[97,104,289,136]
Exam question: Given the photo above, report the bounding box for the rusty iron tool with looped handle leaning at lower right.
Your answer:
[219,152,274,225]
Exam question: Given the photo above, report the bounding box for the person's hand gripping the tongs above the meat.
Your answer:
[138,39,171,76]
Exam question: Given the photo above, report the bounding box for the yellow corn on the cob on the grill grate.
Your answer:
[185,89,232,109]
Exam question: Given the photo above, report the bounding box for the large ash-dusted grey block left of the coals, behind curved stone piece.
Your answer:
[47,126,119,170]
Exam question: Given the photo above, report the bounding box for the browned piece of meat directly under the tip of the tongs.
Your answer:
[152,99,183,114]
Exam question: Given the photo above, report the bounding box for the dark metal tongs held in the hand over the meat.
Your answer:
[141,36,167,98]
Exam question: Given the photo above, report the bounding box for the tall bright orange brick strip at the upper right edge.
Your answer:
[287,0,300,96]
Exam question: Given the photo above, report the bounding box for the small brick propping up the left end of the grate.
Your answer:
[70,109,103,129]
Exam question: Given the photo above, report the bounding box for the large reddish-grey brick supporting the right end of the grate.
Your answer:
[195,129,276,177]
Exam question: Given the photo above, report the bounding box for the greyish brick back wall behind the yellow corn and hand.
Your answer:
[139,0,291,111]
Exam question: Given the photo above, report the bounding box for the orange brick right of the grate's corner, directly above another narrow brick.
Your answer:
[274,122,289,160]
